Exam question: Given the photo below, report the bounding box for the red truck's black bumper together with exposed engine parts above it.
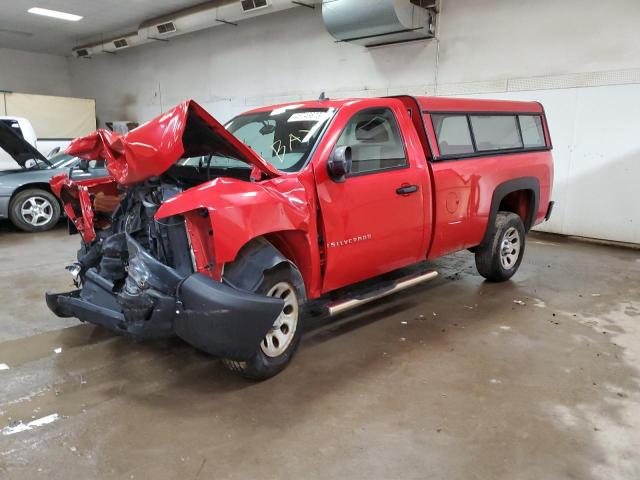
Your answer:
[46,180,283,360]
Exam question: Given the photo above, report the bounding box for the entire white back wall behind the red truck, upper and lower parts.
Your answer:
[69,0,640,243]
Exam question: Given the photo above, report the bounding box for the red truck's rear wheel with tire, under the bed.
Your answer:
[475,212,525,282]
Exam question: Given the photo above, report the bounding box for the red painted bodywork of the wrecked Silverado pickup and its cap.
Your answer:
[52,96,553,298]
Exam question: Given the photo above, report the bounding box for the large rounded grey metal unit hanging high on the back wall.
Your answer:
[322,0,436,47]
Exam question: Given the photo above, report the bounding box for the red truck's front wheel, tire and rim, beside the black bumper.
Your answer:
[222,265,306,380]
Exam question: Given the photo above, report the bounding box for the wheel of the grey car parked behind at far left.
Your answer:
[9,188,61,232]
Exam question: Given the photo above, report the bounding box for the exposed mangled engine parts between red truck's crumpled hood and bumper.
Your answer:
[69,179,188,328]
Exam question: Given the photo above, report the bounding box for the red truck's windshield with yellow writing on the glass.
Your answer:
[180,105,334,172]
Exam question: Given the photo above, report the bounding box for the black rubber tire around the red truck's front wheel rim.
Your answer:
[222,265,307,380]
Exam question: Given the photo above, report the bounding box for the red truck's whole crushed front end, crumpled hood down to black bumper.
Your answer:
[46,101,284,361]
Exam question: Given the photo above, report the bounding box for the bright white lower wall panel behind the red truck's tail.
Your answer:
[470,83,640,243]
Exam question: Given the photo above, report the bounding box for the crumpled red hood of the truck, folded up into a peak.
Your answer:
[66,100,280,185]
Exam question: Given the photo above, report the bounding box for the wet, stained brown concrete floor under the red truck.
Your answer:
[0,224,640,480]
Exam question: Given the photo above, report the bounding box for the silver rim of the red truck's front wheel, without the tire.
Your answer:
[260,282,299,357]
